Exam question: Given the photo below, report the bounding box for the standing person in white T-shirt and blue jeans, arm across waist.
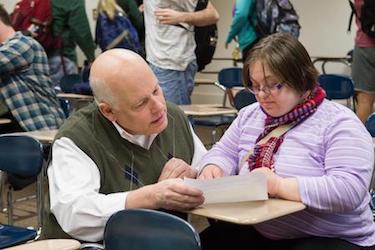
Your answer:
[143,0,219,105]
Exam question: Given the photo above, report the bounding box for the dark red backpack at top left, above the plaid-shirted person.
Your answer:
[11,0,62,52]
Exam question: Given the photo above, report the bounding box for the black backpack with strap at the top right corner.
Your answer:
[348,0,375,38]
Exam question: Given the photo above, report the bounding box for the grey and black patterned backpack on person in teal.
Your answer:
[253,0,301,38]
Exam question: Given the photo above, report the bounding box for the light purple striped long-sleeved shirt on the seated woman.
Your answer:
[199,100,375,246]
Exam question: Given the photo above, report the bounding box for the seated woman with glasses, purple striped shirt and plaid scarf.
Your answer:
[199,33,375,250]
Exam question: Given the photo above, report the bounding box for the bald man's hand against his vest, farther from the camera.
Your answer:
[158,158,197,182]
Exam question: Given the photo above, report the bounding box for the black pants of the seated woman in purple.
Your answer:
[200,221,375,250]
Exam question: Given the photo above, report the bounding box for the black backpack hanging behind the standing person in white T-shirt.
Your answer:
[194,0,218,71]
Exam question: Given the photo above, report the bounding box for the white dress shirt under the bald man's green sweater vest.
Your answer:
[48,123,207,242]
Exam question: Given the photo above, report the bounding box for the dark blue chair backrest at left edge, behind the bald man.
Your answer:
[0,135,43,177]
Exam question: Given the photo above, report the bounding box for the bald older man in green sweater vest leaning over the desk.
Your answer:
[43,49,206,242]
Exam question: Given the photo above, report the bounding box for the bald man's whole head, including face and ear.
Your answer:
[90,49,168,135]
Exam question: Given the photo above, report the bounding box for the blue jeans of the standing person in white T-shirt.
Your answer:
[150,60,198,105]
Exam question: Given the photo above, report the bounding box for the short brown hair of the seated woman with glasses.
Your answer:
[242,33,318,93]
